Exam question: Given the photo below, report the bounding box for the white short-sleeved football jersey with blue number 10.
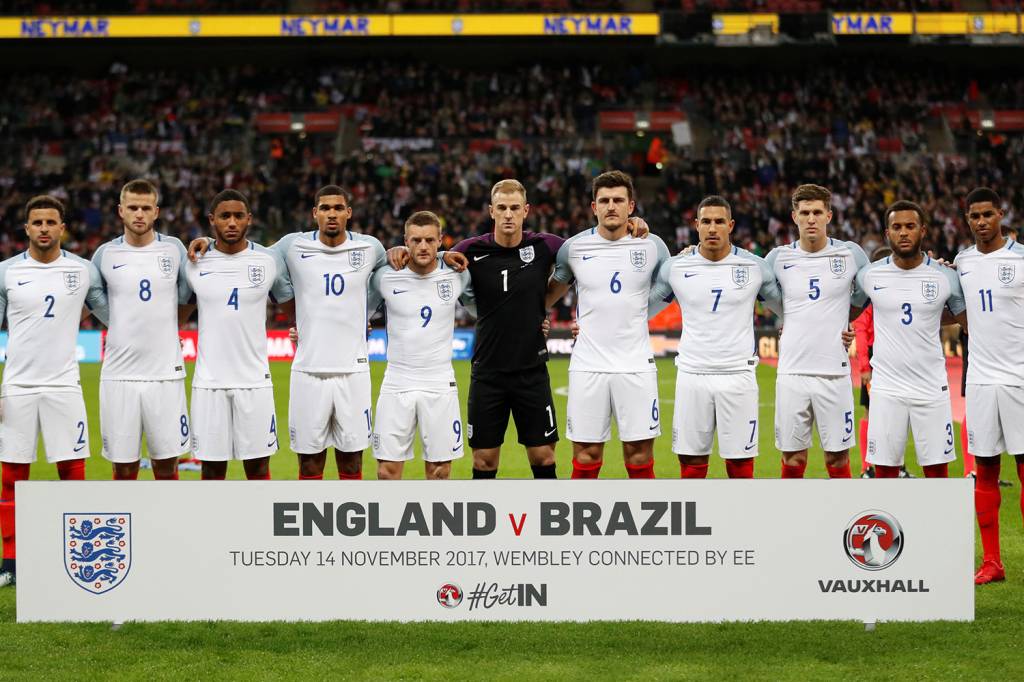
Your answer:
[271,230,387,374]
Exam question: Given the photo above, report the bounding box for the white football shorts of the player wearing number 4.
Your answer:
[191,386,278,462]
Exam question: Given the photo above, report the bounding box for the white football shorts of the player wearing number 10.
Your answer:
[288,370,372,455]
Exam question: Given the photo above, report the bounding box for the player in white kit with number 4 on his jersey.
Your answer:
[185,189,291,480]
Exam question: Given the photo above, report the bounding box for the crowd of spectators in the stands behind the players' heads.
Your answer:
[0,59,1024,270]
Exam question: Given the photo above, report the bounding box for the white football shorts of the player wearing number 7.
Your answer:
[672,372,759,460]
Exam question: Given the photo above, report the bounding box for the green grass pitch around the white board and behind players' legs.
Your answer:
[0,359,1024,680]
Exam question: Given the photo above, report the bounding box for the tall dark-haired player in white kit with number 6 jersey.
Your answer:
[545,171,669,478]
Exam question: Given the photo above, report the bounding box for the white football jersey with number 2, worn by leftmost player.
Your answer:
[0,250,106,395]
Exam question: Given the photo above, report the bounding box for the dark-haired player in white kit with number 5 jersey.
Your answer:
[765,184,867,478]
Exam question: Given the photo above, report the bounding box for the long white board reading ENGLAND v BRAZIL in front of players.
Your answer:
[17,479,974,622]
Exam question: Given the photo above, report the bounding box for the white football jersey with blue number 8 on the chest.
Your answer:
[92,232,191,381]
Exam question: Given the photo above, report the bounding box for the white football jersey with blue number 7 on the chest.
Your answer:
[654,247,780,374]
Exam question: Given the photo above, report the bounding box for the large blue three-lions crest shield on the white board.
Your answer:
[63,513,131,594]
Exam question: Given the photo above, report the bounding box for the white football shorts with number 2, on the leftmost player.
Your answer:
[0,388,89,464]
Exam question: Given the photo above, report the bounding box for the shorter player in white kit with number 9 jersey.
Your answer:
[370,211,470,479]
